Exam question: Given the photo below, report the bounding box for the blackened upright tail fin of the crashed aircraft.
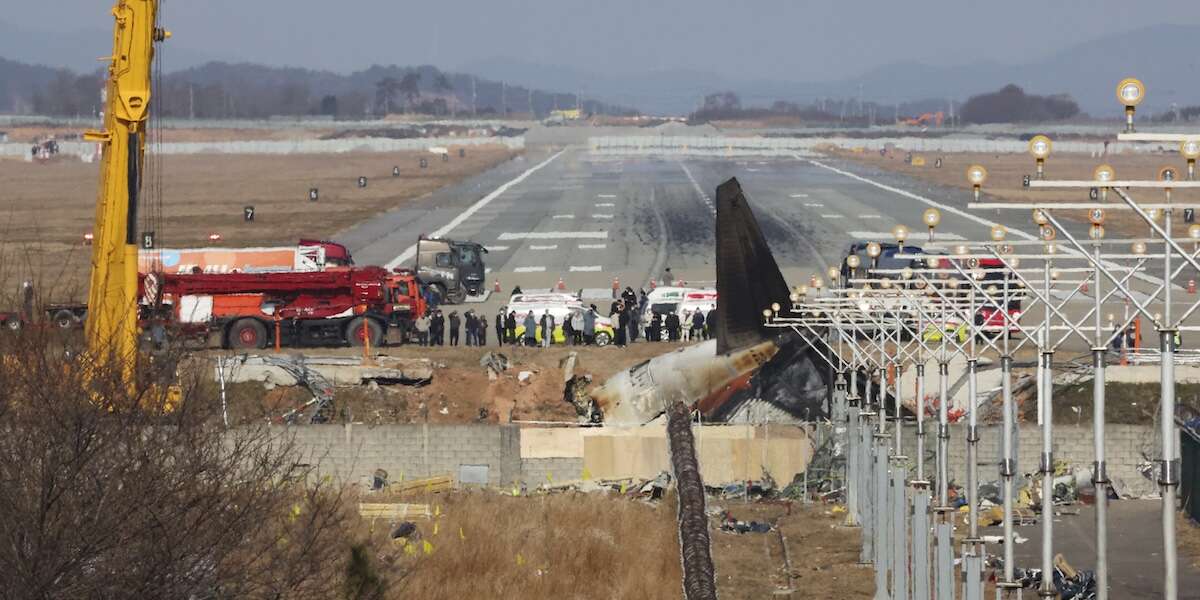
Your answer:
[716,178,791,354]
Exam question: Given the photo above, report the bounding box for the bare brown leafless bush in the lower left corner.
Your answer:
[0,328,349,599]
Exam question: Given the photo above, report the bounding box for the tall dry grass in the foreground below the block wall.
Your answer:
[350,491,874,600]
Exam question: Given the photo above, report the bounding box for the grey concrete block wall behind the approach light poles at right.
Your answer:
[902,421,1158,494]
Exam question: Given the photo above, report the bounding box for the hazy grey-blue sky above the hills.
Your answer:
[9,0,1200,80]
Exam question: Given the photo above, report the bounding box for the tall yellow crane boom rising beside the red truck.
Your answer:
[84,0,170,380]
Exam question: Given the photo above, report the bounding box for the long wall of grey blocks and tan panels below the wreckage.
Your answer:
[276,425,812,486]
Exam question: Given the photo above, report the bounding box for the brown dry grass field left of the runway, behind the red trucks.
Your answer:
[0,145,514,306]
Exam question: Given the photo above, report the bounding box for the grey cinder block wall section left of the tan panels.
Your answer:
[280,425,521,486]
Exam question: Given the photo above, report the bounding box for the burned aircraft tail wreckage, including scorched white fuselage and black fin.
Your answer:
[565,179,832,425]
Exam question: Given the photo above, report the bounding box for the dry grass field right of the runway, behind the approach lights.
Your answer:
[835,149,1200,238]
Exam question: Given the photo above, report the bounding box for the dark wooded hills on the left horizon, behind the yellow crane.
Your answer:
[0,59,631,119]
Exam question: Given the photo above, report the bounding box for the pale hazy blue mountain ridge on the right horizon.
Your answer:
[463,25,1200,116]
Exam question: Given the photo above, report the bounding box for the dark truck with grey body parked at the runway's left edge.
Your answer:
[416,236,487,304]
